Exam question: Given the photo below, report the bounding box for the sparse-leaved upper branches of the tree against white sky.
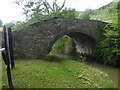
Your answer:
[15,0,66,17]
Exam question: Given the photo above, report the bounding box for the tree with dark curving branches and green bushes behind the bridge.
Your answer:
[12,0,77,26]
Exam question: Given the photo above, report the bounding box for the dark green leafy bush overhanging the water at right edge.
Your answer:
[97,25,120,65]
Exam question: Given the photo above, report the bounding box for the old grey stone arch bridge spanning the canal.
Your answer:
[13,17,106,59]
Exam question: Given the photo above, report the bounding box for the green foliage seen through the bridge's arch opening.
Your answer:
[51,35,76,55]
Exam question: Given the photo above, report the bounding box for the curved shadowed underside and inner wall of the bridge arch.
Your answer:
[48,32,96,55]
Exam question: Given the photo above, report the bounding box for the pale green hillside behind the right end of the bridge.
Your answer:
[79,2,118,23]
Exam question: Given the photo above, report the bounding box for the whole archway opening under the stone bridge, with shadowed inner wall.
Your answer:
[49,32,96,56]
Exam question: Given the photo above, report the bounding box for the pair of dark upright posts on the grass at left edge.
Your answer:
[1,26,15,89]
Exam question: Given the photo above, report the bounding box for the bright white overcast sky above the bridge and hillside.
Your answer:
[0,0,114,24]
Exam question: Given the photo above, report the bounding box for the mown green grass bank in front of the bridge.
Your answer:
[2,60,116,88]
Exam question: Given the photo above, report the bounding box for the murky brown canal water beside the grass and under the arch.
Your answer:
[52,54,120,87]
